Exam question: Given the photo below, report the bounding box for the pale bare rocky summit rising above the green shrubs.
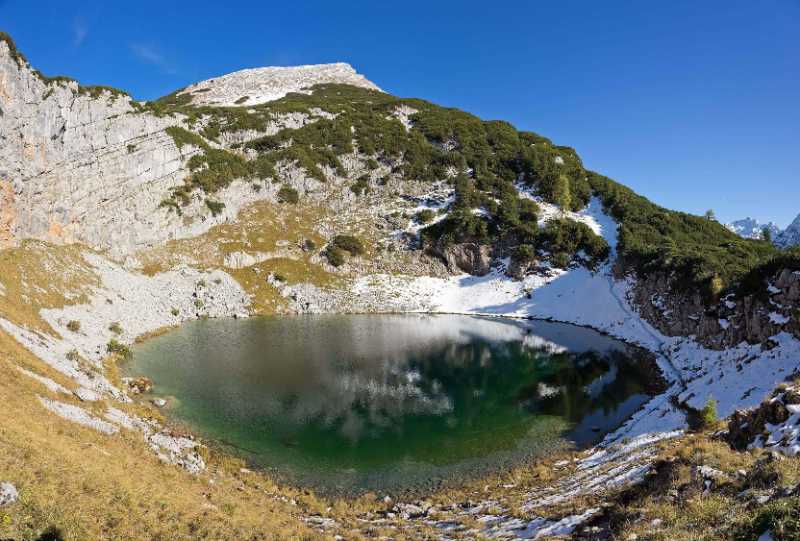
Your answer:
[179,62,381,106]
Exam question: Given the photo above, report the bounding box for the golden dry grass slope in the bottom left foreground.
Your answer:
[0,334,336,540]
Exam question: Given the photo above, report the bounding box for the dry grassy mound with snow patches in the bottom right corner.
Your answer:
[592,432,800,541]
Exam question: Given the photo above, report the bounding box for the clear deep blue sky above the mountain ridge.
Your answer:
[0,0,800,226]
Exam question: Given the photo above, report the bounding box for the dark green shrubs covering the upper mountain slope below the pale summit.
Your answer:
[147,85,777,302]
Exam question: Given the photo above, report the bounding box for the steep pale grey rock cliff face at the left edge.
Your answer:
[0,42,206,255]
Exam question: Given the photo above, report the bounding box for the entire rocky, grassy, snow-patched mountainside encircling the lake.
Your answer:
[0,33,800,539]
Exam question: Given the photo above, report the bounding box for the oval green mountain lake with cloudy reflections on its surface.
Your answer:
[126,315,653,492]
